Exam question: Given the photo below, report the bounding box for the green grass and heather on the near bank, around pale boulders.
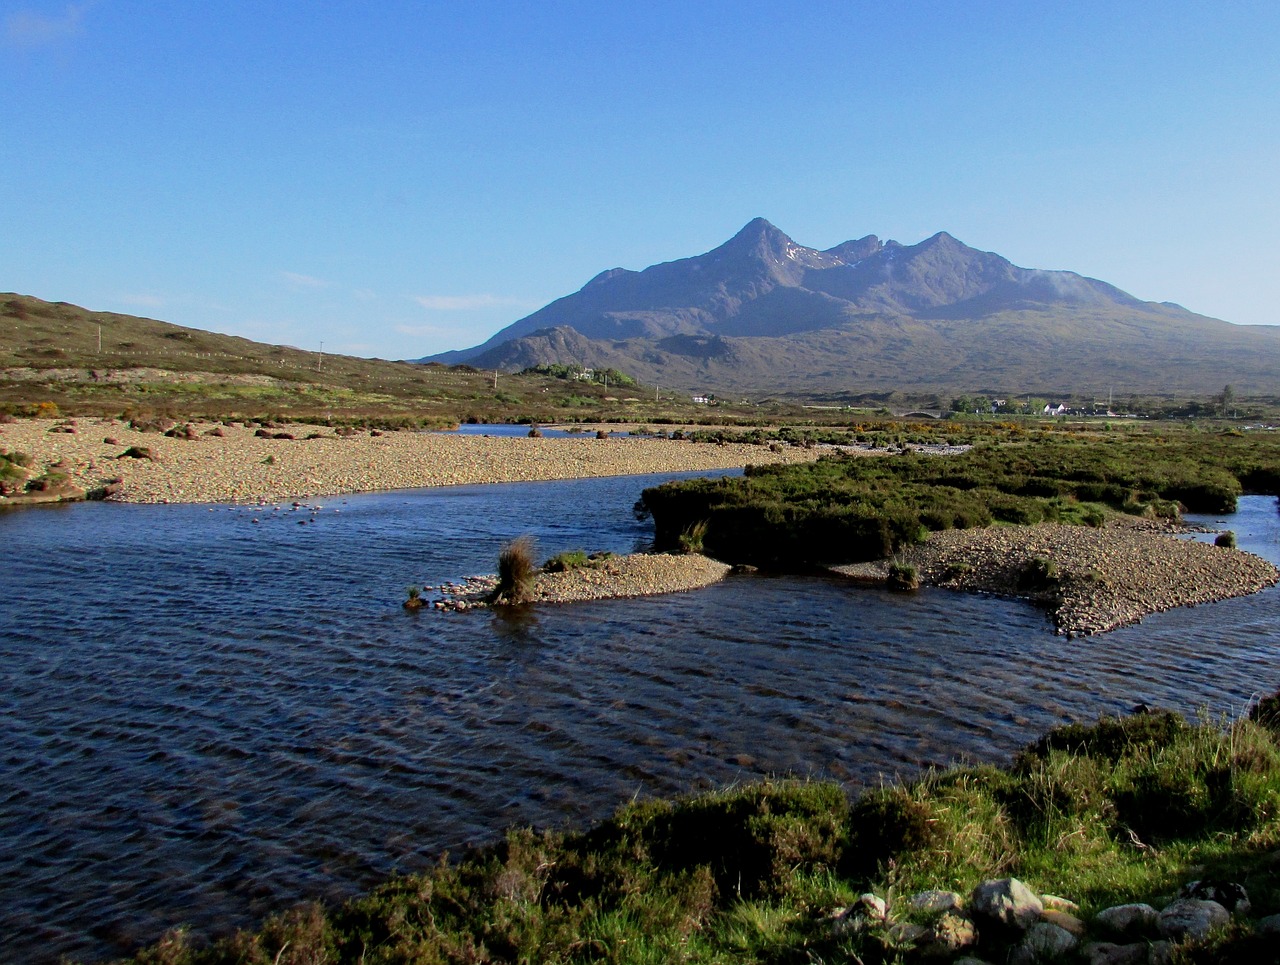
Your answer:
[117,695,1280,965]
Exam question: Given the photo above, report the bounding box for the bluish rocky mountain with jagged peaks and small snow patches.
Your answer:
[420,218,1280,395]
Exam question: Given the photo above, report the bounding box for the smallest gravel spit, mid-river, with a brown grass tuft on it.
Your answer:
[425,553,732,610]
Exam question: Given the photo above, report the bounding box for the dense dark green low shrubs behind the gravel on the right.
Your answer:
[644,425,1280,566]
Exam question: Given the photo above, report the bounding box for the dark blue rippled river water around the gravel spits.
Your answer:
[0,477,1280,961]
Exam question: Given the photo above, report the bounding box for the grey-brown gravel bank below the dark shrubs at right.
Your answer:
[836,521,1280,636]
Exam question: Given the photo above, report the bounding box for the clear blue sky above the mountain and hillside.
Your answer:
[0,0,1280,358]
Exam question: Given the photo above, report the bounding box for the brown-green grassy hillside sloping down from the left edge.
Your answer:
[0,293,785,425]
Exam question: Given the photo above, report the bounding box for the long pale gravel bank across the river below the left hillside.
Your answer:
[0,419,818,503]
